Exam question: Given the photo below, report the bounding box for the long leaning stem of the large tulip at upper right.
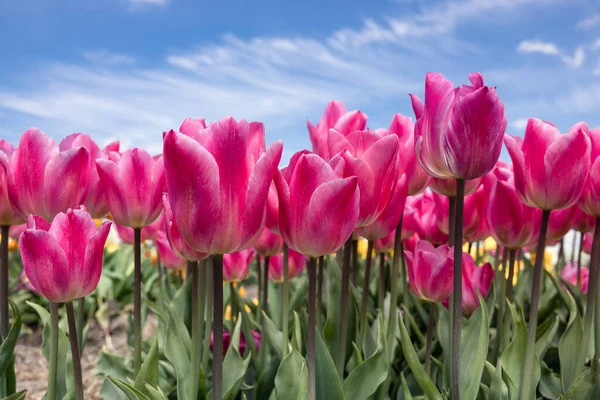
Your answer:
[519,210,550,399]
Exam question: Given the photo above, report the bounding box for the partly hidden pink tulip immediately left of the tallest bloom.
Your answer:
[383,114,430,196]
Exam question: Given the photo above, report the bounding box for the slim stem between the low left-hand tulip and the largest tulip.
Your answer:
[133,228,142,376]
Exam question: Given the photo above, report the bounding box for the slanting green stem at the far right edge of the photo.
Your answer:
[575,218,600,376]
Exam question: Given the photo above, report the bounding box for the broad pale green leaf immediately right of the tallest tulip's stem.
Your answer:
[460,293,489,400]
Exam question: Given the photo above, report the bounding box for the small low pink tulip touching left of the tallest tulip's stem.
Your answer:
[404,240,454,303]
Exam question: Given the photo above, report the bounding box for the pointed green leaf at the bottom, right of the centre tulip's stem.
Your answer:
[309,327,344,400]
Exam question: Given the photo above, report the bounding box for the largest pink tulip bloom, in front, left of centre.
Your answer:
[164,117,283,254]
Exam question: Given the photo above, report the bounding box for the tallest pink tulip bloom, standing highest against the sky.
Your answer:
[410,72,507,180]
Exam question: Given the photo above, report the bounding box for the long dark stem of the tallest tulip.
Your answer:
[451,179,465,400]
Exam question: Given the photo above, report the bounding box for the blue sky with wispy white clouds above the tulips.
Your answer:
[0,0,600,162]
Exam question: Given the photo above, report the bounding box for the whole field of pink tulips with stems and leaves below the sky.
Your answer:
[0,73,600,400]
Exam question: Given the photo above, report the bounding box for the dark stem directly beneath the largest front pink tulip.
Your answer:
[212,254,221,400]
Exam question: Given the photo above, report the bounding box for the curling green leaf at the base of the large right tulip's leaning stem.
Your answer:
[501,301,540,399]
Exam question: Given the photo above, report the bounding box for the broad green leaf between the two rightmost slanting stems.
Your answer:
[558,292,583,392]
